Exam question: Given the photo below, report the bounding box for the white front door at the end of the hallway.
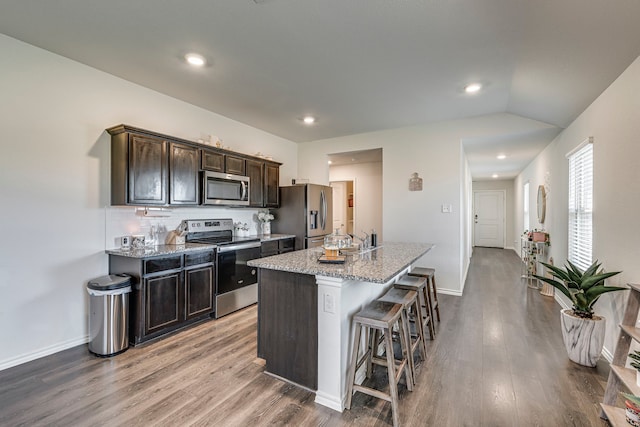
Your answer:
[473,190,505,248]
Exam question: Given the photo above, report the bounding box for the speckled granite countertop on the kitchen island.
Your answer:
[247,242,434,283]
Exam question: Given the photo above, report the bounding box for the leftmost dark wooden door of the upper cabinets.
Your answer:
[128,135,167,205]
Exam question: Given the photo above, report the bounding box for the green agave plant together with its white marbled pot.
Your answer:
[534,261,627,367]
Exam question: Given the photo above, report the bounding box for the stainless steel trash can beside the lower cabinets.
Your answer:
[87,274,131,357]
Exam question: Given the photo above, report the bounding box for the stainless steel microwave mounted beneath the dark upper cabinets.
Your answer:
[202,171,251,206]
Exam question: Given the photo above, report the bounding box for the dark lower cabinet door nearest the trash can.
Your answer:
[144,271,184,335]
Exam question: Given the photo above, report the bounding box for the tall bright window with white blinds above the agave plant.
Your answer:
[567,138,593,269]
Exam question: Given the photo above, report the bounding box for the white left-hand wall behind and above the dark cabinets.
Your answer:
[0,35,297,369]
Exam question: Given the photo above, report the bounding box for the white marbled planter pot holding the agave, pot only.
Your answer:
[560,310,606,367]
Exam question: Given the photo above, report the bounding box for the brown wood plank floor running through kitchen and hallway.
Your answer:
[0,248,609,427]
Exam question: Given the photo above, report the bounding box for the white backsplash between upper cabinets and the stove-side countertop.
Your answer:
[104,206,260,249]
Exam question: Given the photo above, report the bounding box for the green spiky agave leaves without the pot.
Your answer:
[534,261,626,319]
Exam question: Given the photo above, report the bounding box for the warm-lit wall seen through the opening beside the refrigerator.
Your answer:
[329,162,384,241]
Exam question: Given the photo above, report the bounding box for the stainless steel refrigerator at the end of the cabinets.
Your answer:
[271,184,333,250]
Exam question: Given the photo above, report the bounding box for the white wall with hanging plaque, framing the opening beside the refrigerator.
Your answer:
[298,114,552,295]
